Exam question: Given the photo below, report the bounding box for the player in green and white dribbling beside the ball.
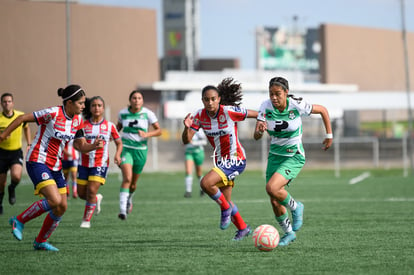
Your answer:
[254,77,332,246]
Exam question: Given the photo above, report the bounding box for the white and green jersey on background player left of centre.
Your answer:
[118,107,158,150]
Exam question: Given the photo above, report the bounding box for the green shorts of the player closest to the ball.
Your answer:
[266,153,305,182]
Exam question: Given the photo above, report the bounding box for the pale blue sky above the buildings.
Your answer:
[78,0,414,69]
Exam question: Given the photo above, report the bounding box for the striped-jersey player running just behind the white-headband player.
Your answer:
[78,96,122,228]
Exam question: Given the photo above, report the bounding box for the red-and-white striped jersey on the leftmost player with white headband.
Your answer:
[26,106,83,171]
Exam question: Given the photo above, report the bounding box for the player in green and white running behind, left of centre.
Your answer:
[117,90,161,220]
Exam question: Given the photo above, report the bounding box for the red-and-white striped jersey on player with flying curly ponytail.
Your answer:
[191,105,247,163]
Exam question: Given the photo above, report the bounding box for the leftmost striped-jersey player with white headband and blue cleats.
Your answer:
[0,85,103,251]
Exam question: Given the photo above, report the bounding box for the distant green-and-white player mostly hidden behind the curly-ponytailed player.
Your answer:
[184,130,207,198]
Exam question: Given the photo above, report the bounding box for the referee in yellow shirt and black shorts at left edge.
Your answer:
[0,93,31,215]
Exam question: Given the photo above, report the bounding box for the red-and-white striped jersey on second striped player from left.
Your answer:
[79,119,120,168]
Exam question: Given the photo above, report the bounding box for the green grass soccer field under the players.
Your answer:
[0,170,414,274]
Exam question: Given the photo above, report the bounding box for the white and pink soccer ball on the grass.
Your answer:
[253,224,280,251]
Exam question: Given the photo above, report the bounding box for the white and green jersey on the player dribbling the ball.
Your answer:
[257,97,312,157]
